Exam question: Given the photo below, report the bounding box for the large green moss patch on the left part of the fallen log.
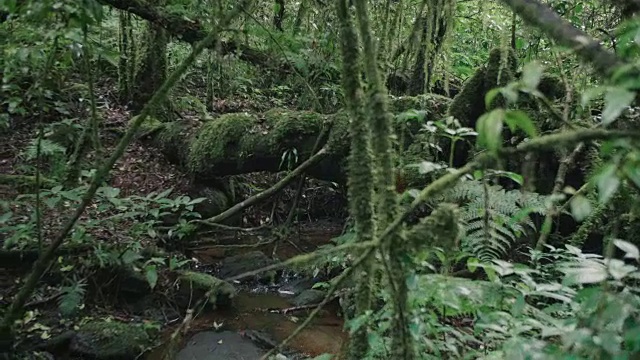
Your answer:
[188,113,255,171]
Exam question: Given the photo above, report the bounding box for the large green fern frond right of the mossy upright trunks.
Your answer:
[435,180,547,261]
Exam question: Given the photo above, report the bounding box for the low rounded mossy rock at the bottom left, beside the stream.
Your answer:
[69,321,151,360]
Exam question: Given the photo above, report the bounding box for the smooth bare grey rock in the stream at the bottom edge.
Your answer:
[176,331,266,360]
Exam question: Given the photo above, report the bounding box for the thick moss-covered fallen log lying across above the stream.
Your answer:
[141,94,451,184]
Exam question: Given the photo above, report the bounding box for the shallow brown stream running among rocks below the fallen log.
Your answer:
[146,224,347,360]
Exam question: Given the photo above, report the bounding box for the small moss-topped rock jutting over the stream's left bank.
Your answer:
[176,271,236,308]
